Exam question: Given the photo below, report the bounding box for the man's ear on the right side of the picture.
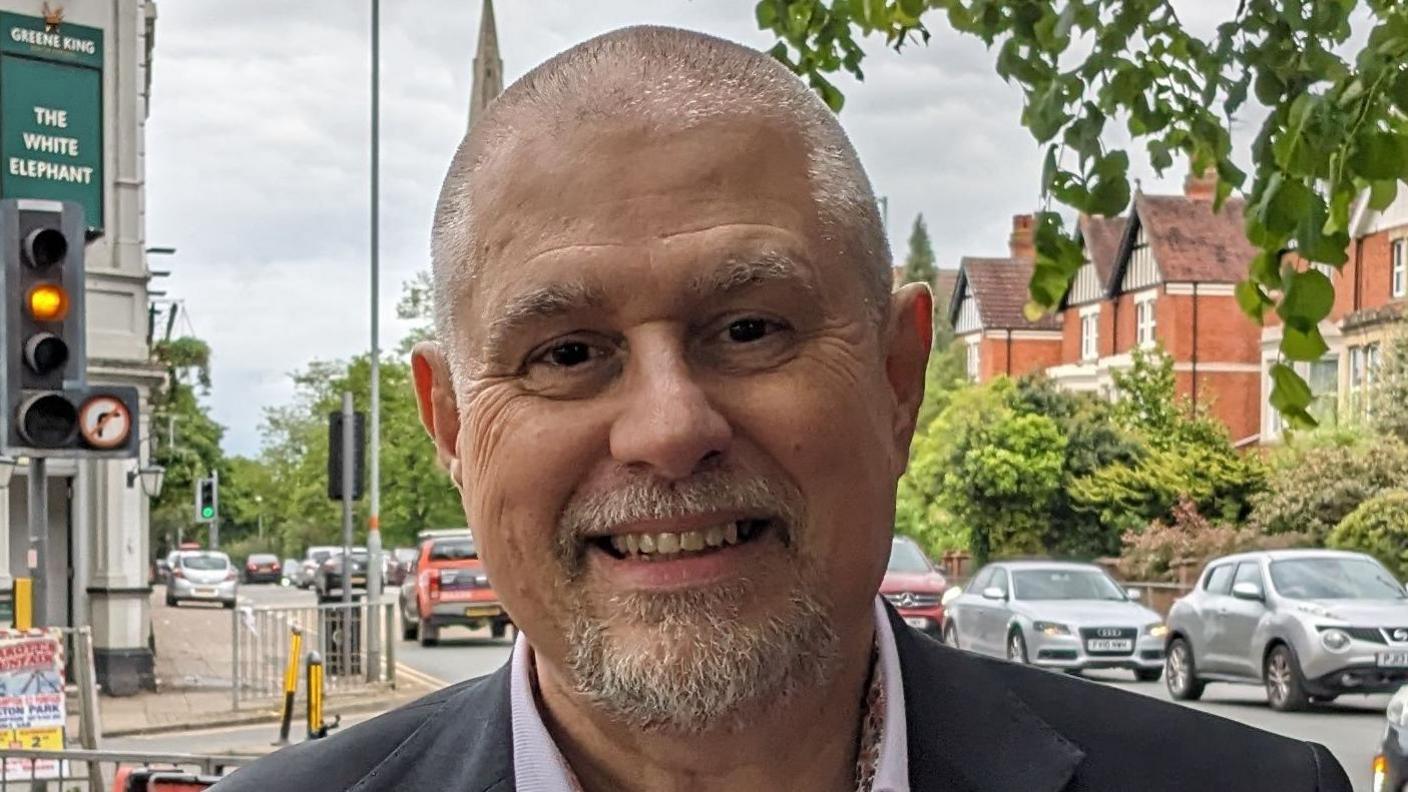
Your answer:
[886,283,934,472]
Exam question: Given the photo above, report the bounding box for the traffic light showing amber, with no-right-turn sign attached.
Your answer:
[0,199,138,457]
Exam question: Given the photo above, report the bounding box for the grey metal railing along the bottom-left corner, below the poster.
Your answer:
[0,748,258,792]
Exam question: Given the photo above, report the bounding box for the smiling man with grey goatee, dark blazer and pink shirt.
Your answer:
[221,28,1349,792]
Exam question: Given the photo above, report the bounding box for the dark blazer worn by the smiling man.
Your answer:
[215,600,1350,792]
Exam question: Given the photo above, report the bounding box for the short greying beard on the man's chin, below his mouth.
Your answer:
[566,574,839,734]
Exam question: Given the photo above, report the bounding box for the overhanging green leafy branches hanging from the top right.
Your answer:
[755,0,1408,426]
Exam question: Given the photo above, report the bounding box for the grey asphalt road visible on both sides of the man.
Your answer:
[129,586,1388,792]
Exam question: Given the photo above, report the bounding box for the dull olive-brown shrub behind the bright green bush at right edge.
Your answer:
[1252,433,1408,541]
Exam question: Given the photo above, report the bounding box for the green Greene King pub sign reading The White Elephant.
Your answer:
[0,13,103,231]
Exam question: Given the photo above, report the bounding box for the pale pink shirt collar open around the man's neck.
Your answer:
[508,596,910,792]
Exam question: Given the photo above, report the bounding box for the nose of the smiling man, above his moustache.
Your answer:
[611,342,732,479]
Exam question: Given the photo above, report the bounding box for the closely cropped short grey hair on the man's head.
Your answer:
[431,27,891,379]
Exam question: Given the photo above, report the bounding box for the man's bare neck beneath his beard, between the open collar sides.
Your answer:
[534,620,874,792]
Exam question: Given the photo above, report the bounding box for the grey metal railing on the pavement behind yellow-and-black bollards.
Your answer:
[230,599,396,709]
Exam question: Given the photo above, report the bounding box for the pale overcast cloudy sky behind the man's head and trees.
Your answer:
[146,0,1221,454]
